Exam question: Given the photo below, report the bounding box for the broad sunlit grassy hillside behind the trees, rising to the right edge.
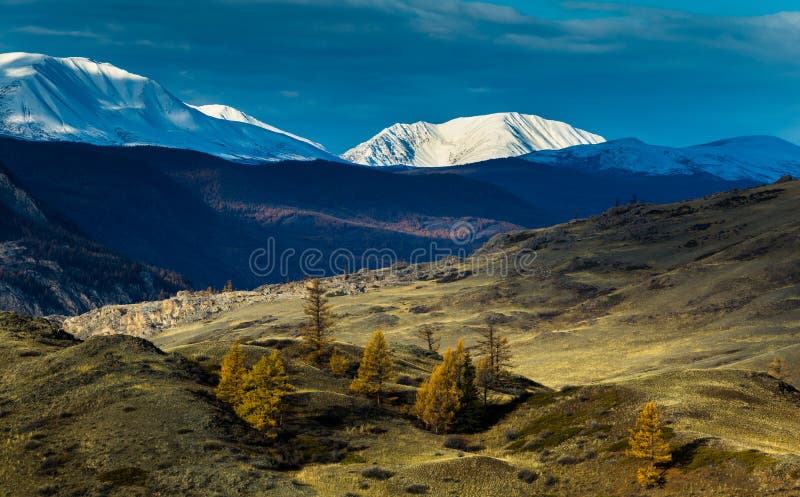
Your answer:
[155,182,800,387]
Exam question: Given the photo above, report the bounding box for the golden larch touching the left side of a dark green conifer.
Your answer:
[414,348,461,433]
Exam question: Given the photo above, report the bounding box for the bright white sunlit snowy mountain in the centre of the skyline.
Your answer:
[342,112,605,167]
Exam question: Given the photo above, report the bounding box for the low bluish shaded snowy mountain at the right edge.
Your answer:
[522,136,800,183]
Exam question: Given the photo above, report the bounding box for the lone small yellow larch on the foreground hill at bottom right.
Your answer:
[625,402,672,486]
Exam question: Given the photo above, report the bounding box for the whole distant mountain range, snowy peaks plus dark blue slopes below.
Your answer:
[0,53,800,314]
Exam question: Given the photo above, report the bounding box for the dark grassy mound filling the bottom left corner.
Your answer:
[0,313,309,497]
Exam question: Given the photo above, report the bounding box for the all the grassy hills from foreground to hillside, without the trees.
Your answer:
[0,180,788,496]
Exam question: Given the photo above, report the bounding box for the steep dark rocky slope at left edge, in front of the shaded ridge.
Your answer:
[0,164,189,315]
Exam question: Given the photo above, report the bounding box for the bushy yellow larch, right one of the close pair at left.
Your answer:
[234,350,291,430]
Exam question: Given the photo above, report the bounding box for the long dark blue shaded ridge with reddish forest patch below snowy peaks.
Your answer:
[0,138,549,294]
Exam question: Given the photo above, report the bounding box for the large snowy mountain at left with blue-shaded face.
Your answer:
[0,53,338,162]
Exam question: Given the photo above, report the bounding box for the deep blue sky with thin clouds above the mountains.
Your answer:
[0,0,800,153]
